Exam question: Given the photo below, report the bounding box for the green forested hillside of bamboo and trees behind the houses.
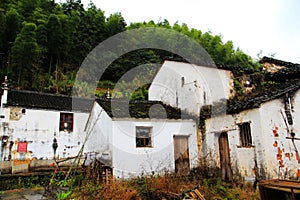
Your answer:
[0,0,257,94]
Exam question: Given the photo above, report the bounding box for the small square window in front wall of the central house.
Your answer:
[136,126,152,147]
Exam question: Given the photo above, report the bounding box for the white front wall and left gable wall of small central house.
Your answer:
[85,103,198,178]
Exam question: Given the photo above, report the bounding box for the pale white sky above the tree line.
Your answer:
[82,0,300,63]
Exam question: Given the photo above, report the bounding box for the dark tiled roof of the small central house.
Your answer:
[96,99,195,119]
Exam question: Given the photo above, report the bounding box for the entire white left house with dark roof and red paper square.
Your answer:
[0,78,92,173]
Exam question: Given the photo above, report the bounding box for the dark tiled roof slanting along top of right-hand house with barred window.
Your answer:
[201,79,300,118]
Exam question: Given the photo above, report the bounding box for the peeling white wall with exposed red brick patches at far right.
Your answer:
[260,92,300,178]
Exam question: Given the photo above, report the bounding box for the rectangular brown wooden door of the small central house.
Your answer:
[174,136,190,175]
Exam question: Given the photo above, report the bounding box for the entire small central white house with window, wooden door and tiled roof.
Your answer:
[85,99,198,178]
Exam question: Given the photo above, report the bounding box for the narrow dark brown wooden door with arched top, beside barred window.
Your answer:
[219,132,232,181]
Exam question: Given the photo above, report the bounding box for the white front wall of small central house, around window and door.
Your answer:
[112,119,198,178]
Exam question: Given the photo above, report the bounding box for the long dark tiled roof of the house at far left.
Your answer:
[6,90,93,112]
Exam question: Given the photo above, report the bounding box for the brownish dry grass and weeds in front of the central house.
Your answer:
[72,174,260,200]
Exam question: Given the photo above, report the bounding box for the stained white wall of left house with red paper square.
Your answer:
[3,107,89,159]
